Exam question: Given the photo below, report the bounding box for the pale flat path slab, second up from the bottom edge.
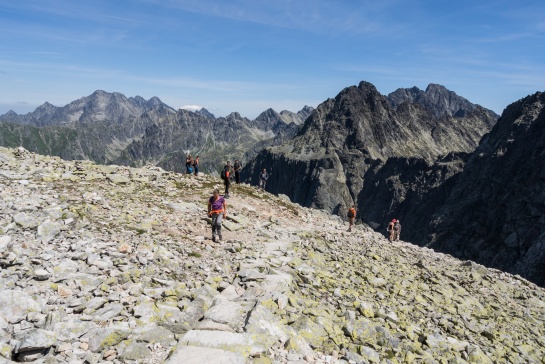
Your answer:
[179,330,267,357]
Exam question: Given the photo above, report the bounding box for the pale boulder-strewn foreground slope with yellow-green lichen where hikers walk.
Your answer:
[0,146,545,364]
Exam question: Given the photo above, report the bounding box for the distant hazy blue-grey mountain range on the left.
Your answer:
[0,91,313,173]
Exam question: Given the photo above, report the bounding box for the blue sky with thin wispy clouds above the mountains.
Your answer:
[0,0,545,118]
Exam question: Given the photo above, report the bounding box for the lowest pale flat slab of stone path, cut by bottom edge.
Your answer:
[165,346,246,364]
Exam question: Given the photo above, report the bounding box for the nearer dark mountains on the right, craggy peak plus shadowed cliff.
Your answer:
[244,82,545,285]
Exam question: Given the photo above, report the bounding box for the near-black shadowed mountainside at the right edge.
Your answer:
[425,93,545,286]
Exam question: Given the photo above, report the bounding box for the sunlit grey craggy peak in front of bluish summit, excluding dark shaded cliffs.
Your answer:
[243,82,495,213]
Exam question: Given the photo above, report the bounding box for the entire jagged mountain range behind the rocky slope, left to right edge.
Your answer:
[0,82,545,286]
